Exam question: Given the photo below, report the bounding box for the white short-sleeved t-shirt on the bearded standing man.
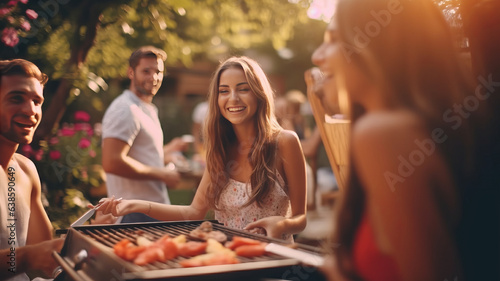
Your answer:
[102,90,170,204]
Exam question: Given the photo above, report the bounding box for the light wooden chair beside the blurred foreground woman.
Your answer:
[305,70,351,203]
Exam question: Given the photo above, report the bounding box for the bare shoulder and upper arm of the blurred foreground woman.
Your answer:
[352,114,461,281]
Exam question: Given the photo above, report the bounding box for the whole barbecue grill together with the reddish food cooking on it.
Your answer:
[54,221,323,281]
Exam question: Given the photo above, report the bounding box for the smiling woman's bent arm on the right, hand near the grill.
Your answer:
[245,130,307,239]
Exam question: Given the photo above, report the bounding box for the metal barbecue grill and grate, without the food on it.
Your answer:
[55,221,324,280]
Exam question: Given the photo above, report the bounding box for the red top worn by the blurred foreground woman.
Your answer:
[353,214,401,281]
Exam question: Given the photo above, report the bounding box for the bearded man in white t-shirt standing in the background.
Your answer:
[102,46,180,223]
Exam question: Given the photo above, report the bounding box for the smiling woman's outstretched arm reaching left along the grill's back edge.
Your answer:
[99,170,210,221]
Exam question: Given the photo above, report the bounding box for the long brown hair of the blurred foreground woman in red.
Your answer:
[332,0,480,280]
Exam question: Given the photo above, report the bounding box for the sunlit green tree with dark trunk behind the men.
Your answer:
[1,0,309,143]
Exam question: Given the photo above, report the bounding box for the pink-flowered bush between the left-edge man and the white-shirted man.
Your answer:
[20,111,104,228]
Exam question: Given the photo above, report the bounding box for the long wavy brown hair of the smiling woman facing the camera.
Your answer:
[203,57,281,209]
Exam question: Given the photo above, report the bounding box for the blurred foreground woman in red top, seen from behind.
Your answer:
[312,0,494,281]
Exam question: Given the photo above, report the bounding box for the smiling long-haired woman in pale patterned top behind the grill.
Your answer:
[97,57,306,241]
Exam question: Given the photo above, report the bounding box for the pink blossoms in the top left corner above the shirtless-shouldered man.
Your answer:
[0,0,38,47]
